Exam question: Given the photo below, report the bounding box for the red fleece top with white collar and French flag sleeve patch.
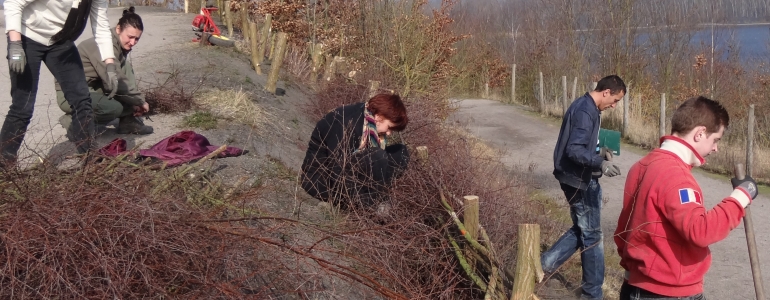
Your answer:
[614,136,751,297]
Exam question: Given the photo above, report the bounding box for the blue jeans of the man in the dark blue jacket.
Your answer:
[540,179,604,299]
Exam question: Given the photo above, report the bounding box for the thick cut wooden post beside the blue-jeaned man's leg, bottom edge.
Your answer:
[511,224,544,300]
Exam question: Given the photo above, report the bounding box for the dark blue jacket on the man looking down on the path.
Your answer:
[553,93,604,190]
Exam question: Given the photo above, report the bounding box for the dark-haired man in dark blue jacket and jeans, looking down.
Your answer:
[540,75,626,299]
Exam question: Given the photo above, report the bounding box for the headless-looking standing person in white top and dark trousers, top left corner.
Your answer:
[0,0,119,167]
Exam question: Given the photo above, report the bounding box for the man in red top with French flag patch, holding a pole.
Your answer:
[614,97,757,300]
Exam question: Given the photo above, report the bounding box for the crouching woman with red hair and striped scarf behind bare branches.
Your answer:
[302,94,409,206]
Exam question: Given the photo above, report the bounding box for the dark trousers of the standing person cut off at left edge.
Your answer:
[0,35,96,166]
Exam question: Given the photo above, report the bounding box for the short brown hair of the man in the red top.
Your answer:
[671,96,730,134]
